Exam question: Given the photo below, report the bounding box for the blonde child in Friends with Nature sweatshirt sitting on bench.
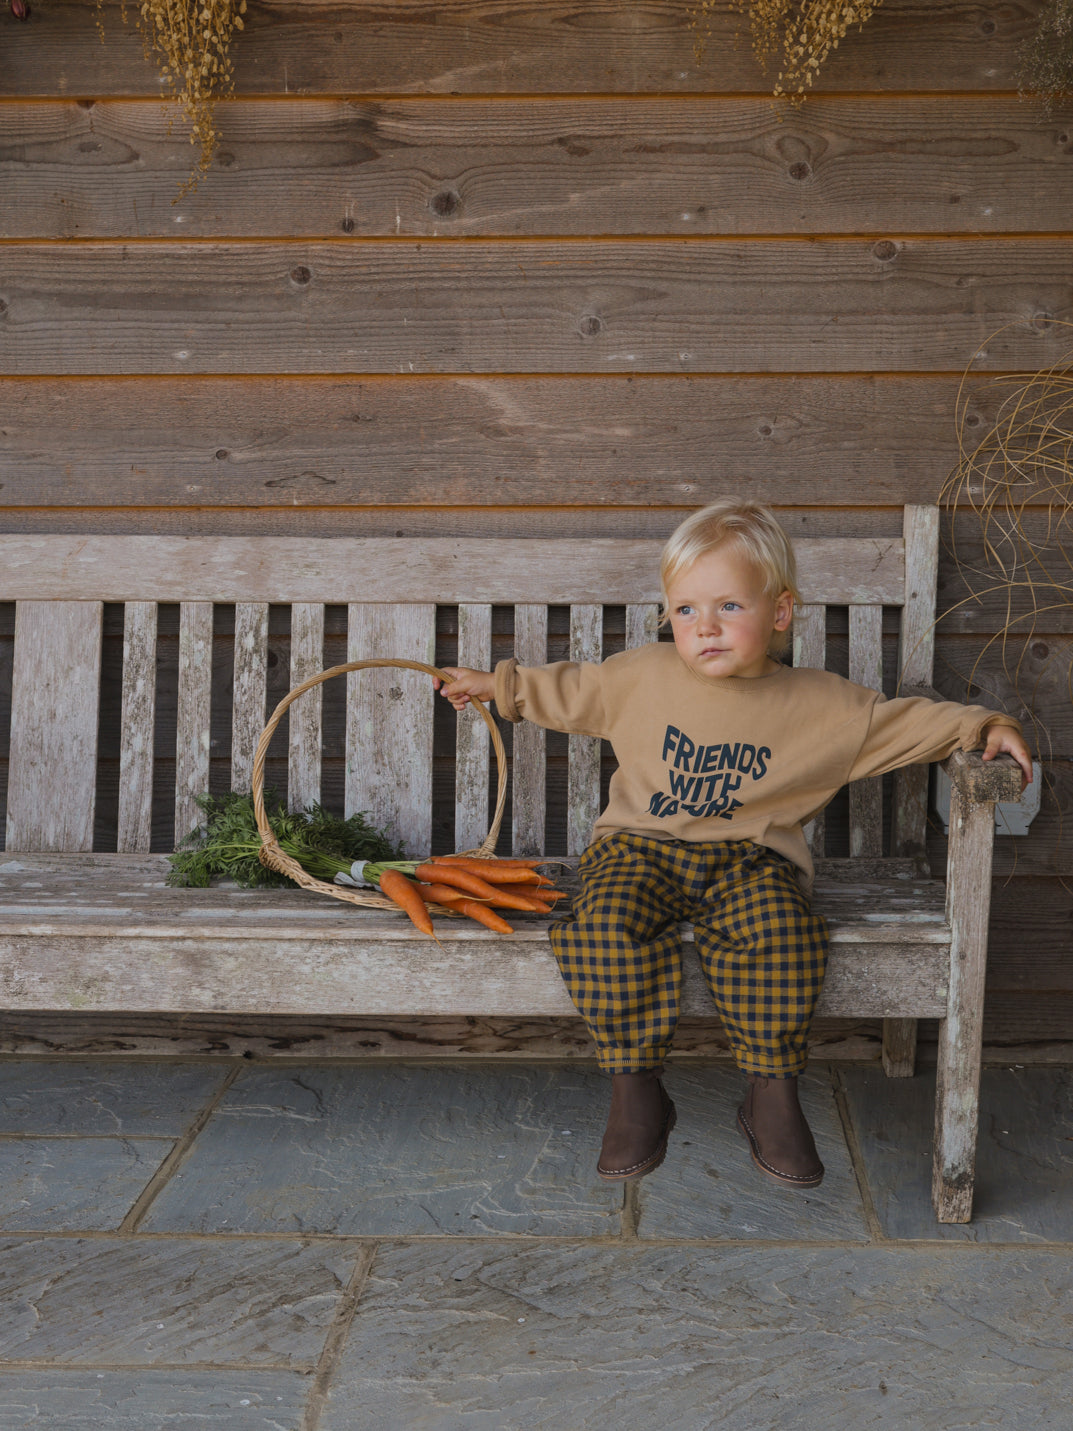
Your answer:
[434,499,1032,1188]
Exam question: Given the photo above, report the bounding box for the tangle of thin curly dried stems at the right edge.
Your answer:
[939,319,1073,778]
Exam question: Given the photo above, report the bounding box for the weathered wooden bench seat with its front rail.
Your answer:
[0,854,950,1017]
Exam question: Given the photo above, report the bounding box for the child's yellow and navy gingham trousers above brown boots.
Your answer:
[549,834,827,1078]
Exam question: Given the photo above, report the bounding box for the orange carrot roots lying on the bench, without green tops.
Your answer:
[363,854,565,939]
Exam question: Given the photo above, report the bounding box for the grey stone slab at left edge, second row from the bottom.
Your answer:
[0,1238,363,1371]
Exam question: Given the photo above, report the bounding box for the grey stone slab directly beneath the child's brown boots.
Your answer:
[637,1068,868,1242]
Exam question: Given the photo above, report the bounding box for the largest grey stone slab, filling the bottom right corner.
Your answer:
[319,1242,1073,1431]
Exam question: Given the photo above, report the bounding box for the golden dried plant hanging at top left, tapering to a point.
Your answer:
[97,0,246,199]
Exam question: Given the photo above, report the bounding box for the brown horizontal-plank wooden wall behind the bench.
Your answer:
[0,0,1073,1045]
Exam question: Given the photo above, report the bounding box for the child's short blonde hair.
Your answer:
[660,497,801,655]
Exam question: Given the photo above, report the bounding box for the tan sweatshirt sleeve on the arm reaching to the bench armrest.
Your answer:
[847,695,1021,780]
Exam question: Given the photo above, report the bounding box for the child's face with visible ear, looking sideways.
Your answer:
[667,542,794,677]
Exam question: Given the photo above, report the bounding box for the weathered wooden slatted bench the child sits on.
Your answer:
[0,507,1020,1222]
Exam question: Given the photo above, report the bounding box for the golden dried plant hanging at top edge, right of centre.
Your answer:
[692,0,883,102]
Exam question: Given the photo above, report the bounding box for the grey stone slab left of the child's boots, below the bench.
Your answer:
[143,1065,622,1236]
